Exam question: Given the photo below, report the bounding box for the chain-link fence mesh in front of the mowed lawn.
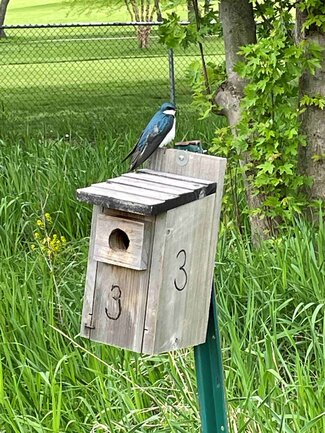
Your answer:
[0,23,224,112]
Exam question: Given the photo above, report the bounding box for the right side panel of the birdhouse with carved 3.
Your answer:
[143,194,215,353]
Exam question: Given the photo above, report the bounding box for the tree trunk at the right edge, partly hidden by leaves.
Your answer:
[296,10,325,200]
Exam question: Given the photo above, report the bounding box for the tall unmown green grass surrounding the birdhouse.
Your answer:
[0,115,325,433]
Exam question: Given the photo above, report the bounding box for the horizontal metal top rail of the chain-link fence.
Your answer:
[0,21,190,30]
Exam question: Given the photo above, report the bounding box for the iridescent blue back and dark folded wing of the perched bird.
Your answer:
[130,114,174,171]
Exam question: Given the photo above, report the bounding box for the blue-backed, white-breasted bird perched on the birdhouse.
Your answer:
[122,102,176,171]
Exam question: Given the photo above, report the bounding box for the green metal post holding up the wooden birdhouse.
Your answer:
[175,141,229,433]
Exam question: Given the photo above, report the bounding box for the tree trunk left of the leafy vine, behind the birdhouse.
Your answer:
[215,0,270,244]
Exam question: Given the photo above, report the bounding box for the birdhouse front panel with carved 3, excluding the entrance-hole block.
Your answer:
[81,206,154,352]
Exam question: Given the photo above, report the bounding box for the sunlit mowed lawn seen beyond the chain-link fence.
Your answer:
[0,0,224,114]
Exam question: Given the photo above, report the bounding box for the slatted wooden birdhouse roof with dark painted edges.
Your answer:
[77,170,216,215]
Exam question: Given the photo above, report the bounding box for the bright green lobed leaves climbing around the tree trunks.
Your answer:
[156,0,324,231]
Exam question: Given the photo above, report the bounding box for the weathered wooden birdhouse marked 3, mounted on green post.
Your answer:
[77,149,225,354]
